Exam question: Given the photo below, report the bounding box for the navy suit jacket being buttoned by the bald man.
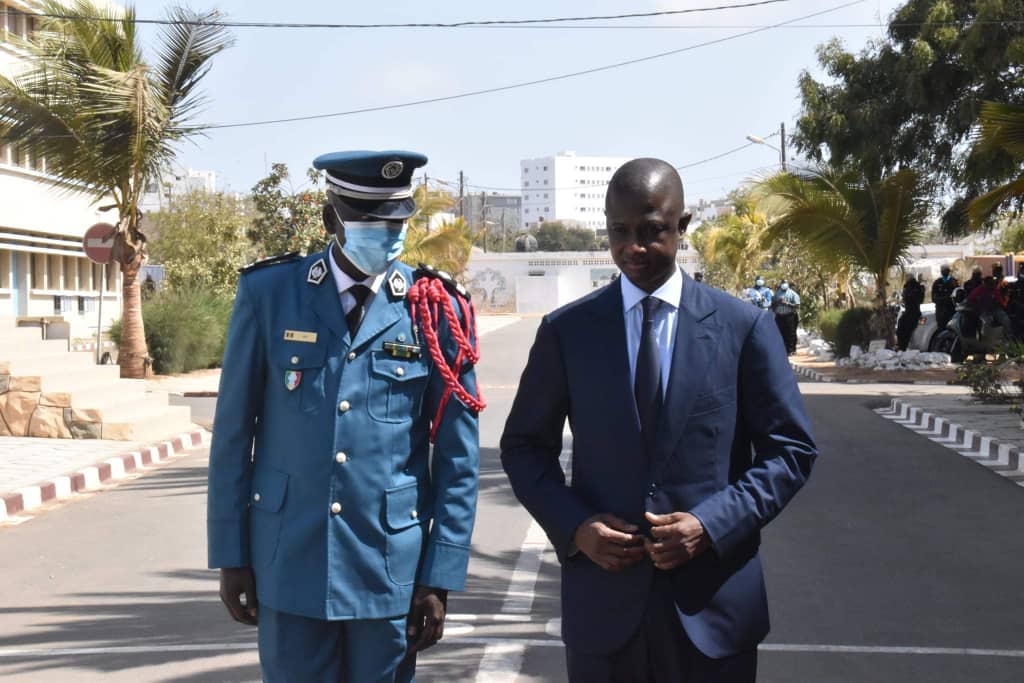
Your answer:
[501,273,817,657]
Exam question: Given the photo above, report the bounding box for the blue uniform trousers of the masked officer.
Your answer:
[259,605,416,683]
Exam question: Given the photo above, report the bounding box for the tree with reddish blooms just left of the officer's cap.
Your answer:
[247,164,332,258]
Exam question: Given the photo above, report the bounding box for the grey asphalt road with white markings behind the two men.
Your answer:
[0,319,1024,683]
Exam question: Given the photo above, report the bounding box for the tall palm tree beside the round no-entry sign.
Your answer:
[0,0,231,378]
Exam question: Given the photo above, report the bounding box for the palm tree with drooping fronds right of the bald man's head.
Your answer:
[758,166,930,338]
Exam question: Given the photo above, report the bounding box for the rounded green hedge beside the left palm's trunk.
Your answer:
[111,290,232,375]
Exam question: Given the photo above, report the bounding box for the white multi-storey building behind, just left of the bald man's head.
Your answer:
[519,152,629,236]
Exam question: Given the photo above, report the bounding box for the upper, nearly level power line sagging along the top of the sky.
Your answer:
[18,0,793,29]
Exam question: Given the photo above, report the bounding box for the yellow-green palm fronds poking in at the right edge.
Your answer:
[968,102,1024,228]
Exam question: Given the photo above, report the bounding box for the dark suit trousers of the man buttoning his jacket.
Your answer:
[565,572,758,683]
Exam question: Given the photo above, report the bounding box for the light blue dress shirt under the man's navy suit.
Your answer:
[621,267,683,398]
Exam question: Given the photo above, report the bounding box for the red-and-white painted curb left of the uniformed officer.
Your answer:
[0,429,210,522]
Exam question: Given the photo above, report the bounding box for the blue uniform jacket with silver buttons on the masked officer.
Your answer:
[208,252,479,620]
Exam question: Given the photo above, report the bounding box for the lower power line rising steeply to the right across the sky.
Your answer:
[201,0,864,129]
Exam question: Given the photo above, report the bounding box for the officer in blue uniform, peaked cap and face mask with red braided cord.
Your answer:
[208,152,482,683]
